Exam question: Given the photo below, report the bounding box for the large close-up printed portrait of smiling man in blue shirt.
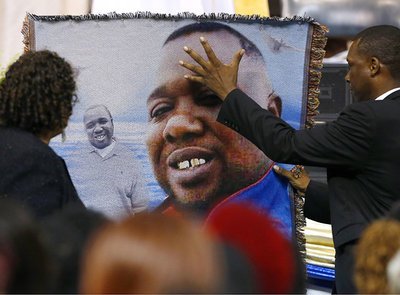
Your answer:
[146,22,292,235]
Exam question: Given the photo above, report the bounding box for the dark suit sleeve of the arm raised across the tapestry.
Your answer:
[217,89,376,167]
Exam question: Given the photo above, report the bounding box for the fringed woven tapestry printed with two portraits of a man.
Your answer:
[23,12,326,245]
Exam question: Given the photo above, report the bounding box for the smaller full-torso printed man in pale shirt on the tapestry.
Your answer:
[68,104,149,220]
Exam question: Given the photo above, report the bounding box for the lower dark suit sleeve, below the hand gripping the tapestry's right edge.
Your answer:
[304,180,331,224]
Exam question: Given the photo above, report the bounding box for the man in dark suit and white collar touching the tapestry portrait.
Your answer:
[180,26,400,293]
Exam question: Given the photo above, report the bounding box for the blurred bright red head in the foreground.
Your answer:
[205,202,306,294]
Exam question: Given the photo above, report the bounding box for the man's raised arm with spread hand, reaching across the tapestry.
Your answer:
[180,39,377,167]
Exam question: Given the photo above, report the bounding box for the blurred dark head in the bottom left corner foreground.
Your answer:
[0,198,49,294]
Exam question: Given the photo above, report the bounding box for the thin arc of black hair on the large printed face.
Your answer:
[164,22,264,60]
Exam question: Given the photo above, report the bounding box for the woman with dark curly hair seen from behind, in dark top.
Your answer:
[0,51,84,217]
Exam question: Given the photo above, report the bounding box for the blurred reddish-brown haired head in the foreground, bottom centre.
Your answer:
[80,213,223,294]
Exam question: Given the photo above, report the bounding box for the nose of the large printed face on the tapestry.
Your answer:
[163,114,204,141]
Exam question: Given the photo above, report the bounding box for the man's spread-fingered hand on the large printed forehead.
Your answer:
[179,37,245,100]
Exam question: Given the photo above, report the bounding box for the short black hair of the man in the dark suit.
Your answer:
[354,25,400,79]
